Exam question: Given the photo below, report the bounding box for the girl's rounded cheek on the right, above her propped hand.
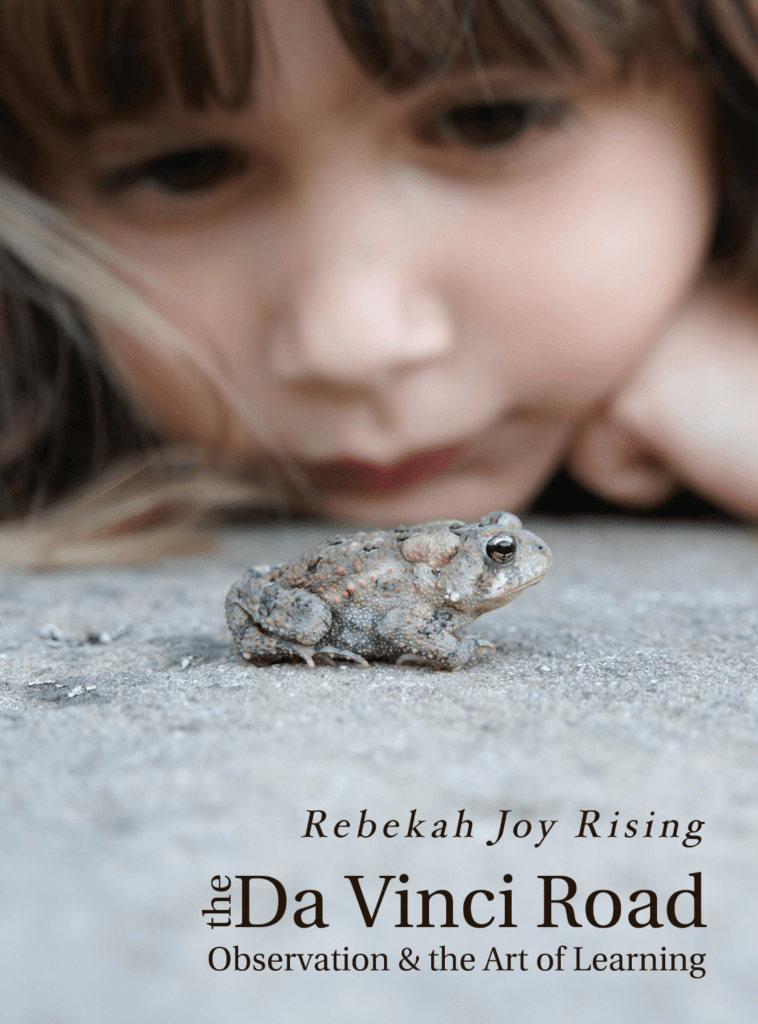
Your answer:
[450,72,715,402]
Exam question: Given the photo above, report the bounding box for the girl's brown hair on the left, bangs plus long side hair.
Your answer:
[0,0,259,532]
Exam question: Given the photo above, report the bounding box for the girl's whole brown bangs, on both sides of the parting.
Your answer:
[0,0,708,182]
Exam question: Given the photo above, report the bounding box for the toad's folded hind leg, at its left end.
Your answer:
[226,569,332,667]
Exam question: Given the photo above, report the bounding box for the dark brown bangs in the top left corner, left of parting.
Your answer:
[0,0,254,159]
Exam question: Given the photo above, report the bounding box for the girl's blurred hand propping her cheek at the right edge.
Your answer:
[569,287,758,521]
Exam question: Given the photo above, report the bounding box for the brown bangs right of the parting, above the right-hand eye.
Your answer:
[327,0,684,90]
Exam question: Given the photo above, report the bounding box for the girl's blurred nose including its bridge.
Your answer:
[267,173,454,388]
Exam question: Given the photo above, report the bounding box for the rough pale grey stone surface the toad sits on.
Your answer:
[0,520,758,1024]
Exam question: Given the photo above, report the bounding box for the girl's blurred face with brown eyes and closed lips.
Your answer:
[50,0,714,520]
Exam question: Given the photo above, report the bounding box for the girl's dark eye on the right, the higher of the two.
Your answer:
[423,100,566,148]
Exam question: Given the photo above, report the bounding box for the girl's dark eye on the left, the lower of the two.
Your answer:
[100,145,249,195]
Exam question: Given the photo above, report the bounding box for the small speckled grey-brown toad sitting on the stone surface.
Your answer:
[226,512,552,670]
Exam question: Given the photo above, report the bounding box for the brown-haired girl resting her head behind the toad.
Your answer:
[0,0,758,557]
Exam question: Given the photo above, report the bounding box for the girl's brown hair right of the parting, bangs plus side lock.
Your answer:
[327,0,758,264]
